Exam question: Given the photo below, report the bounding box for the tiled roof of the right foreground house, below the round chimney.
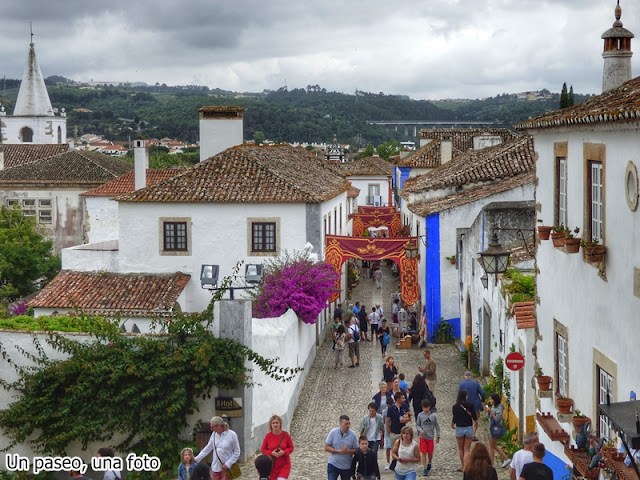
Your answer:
[515,77,640,130]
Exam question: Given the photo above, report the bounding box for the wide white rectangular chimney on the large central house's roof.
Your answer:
[198,106,244,162]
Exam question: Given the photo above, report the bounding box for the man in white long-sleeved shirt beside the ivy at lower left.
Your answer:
[195,417,240,480]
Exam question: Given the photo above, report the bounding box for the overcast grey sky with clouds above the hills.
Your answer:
[0,0,640,99]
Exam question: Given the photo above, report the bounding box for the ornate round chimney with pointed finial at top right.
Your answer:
[602,0,634,92]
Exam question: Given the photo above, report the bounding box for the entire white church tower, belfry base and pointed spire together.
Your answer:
[0,43,67,145]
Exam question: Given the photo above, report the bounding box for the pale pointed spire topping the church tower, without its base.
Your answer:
[13,42,54,117]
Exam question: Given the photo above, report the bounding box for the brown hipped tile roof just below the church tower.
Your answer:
[0,150,133,186]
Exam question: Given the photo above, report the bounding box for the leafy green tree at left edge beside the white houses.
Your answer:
[0,207,60,301]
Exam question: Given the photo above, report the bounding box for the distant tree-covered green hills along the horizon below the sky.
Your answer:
[0,76,586,146]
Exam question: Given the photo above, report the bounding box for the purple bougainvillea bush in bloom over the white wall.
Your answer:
[253,256,338,323]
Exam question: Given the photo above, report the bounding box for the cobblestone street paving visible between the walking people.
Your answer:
[242,265,509,480]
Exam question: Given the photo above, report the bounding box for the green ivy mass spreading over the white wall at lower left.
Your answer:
[0,284,302,477]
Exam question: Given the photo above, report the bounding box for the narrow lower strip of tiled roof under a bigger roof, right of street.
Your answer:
[408,172,536,213]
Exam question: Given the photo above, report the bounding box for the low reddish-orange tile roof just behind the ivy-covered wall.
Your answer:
[29,270,191,317]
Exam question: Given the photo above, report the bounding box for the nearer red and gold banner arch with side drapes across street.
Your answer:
[324,235,420,305]
